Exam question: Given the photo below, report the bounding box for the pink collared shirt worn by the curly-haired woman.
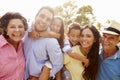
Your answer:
[0,35,25,80]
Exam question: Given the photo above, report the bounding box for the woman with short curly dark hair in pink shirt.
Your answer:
[0,12,28,80]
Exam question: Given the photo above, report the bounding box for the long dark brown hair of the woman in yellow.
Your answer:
[81,26,100,80]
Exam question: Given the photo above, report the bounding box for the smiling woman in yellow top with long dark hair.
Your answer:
[65,25,100,80]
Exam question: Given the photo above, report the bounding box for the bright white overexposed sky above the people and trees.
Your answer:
[0,0,120,23]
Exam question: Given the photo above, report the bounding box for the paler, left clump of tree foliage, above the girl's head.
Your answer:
[54,1,77,25]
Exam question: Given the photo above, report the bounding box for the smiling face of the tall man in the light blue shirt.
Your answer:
[35,9,53,32]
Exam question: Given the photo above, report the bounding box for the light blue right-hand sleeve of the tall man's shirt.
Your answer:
[47,38,63,77]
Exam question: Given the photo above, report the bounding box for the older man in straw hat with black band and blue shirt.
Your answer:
[97,21,120,80]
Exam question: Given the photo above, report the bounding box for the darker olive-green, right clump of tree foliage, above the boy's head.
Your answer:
[75,5,96,26]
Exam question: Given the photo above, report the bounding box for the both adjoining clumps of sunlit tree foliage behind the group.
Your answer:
[54,1,95,26]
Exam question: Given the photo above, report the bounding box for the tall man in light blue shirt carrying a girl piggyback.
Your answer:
[24,7,63,80]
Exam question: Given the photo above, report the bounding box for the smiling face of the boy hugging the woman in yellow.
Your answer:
[68,29,80,45]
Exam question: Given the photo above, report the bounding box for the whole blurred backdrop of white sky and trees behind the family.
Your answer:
[0,0,120,31]
